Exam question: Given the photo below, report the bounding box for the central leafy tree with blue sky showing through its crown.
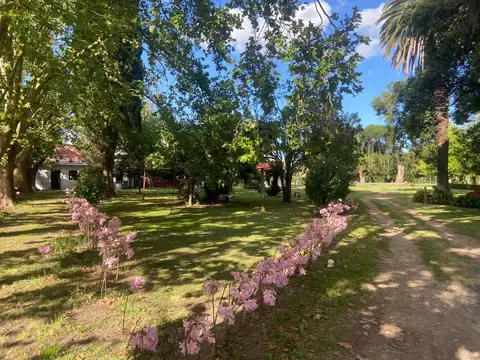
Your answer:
[236,2,366,202]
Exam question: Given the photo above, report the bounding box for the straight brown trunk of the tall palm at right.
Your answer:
[434,89,450,191]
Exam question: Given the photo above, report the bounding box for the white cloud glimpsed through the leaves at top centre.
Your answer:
[231,1,332,52]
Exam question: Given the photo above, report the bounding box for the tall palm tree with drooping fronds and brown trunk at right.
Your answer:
[378,0,449,191]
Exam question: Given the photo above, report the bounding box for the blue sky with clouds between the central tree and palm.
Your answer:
[225,0,405,126]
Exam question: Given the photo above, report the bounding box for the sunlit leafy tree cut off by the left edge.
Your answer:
[0,0,131,208]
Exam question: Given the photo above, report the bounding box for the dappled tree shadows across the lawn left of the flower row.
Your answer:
[0,191,313,319]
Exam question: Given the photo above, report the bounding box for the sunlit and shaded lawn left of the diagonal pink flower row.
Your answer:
[0,189,313,359]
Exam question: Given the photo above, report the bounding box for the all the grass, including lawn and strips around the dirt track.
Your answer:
[0,185,480,360]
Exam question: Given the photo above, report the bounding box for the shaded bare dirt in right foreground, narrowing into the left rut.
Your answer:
[337,197,480,360]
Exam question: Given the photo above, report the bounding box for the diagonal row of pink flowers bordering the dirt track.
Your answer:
[180,200,357,356]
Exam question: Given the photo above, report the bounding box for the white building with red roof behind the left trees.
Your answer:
[35,145,87,190]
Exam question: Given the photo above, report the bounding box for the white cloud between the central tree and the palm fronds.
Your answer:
[357,3,384,59]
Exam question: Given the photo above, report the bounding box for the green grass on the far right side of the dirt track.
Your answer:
[352,184,480,240]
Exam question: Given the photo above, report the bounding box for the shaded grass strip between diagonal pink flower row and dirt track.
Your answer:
[142,204,388,359]
